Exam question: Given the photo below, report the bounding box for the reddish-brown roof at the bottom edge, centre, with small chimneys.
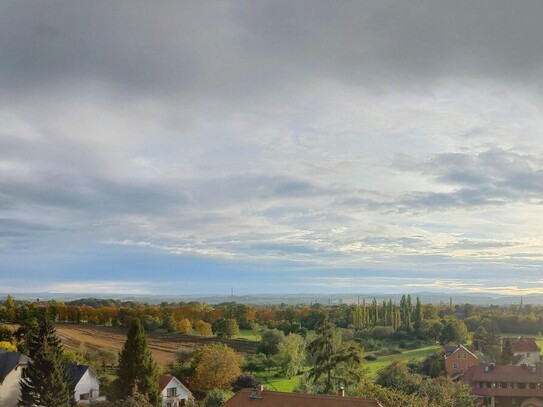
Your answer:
[222,386,382,407]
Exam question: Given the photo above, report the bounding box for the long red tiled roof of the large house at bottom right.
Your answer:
[464,365,543,387]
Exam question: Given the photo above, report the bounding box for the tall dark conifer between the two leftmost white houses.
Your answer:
[20,315,72,407]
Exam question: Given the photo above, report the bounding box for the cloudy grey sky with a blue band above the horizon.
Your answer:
[0,0,543,295]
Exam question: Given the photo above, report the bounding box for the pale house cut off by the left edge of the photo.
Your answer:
[0,350,28,407]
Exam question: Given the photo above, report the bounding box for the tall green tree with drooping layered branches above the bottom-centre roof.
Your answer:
[307,316,363,394]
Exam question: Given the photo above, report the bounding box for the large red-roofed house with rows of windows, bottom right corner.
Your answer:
[464,365,543,407]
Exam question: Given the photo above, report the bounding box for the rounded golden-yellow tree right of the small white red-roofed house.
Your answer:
[191,343,242,393]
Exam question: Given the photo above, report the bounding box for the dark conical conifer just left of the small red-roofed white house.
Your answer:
[113,319,160,406]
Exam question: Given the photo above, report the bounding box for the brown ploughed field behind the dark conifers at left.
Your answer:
[56,324,257,365]
